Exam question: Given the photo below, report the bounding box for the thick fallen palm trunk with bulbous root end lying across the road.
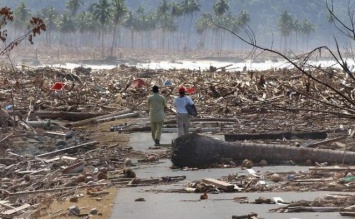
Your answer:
[171,133,355,167]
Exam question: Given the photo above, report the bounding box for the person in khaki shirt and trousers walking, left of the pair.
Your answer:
[148,85,166,146]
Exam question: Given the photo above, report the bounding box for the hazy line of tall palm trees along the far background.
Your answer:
[6,0,336,56]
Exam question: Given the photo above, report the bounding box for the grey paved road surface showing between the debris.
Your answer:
[111,133,354,219]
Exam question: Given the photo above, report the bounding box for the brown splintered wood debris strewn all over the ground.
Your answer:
[0,65,355,218]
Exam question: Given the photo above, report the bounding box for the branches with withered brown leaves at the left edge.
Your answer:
[0,7,46,126]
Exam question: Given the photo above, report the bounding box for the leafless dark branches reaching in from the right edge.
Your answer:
[211,0,355,118]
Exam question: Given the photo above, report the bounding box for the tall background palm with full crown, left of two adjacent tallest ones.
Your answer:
[90,0,112,57]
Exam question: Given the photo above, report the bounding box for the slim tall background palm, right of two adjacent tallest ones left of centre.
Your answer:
[111,0,127,56]
